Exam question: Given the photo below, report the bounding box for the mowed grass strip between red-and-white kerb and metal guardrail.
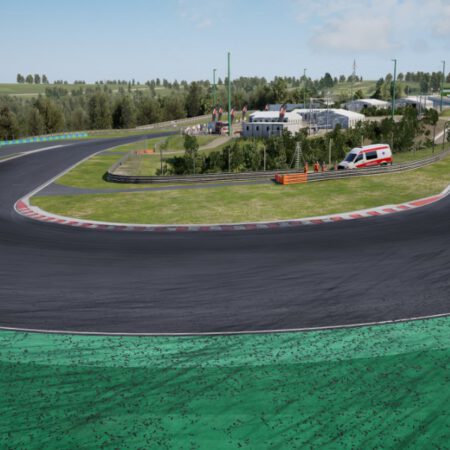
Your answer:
[32,149,450,224]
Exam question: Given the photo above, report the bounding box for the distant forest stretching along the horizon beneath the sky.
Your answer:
[0,72,450,140]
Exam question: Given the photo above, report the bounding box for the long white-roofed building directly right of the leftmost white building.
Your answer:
[292,108,366,130]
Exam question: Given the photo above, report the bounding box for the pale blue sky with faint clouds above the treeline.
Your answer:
[0,0,450,82]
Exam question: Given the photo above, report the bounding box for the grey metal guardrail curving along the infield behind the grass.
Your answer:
[106,149,450,184]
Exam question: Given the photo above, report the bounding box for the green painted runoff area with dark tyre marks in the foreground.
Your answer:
[0,317,450,450]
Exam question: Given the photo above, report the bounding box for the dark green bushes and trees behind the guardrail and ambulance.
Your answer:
[162,107,439,175]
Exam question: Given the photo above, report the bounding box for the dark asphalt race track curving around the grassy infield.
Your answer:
[0,136,450,334]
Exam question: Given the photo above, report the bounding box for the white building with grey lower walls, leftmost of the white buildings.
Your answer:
[242,111,305,137]
